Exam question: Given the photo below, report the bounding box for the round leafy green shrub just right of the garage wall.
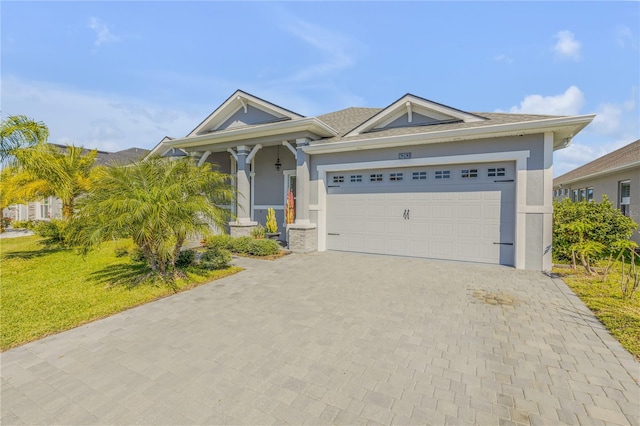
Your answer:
[553,196,638,271]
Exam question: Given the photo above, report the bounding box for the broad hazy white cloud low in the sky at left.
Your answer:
[2,76,202,151]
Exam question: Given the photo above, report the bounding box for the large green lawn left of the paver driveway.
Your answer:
[0,236,241,350]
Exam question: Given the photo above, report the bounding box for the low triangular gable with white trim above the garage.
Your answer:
[345,94,486,136]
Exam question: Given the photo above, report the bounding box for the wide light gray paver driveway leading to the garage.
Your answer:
[1,253,640,425]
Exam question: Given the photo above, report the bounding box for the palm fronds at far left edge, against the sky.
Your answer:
[0,115,49,163]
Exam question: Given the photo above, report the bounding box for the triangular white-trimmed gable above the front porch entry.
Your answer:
[187,90,304,137]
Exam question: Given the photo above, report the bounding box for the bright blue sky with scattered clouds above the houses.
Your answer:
[0,1,640,176]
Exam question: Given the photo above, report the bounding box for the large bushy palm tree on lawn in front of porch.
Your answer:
[76,157,235,276]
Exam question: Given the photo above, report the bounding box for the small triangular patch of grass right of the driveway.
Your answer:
[553,264,640,361]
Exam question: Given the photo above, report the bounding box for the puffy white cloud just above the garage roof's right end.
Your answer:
[509,86,584,115]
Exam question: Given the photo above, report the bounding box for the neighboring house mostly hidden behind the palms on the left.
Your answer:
[4,144,149,220]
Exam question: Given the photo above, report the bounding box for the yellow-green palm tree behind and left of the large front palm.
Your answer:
[12,144,98,219]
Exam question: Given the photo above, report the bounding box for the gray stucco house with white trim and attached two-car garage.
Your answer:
[153,90,594,270]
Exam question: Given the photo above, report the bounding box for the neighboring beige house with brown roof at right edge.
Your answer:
[553,139,640,244]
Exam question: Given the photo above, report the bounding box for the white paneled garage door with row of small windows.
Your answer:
[327,163,515,265]
